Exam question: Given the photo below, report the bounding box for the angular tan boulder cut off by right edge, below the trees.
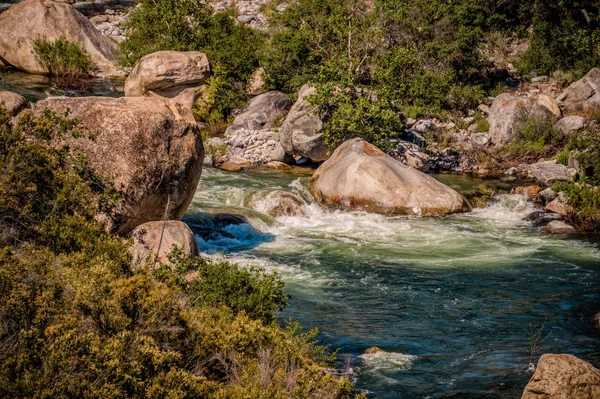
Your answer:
[556,68,600,113]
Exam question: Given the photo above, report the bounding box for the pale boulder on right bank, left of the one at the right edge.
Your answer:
[488,93,561,145]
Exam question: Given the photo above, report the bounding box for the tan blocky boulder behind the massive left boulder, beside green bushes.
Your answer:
[125,51,210,98]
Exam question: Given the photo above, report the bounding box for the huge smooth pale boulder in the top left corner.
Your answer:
[0,0,123,76]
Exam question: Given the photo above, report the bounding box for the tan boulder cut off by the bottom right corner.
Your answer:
[521,354,600,399]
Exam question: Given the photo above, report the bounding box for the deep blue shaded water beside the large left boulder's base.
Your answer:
[183,212,275,254]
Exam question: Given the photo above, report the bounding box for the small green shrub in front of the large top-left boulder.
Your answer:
[34,37,94,88]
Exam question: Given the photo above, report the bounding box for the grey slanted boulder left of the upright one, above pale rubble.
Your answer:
[226,91,292,134]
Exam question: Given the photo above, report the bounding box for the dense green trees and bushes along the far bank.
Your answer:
[122,0,599,147]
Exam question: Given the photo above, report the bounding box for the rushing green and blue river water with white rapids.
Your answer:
[184,168,600,398]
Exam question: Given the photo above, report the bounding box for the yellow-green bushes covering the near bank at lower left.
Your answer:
[0,110,364,399]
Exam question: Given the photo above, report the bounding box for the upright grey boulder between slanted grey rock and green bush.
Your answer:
[279,85,328,162]
